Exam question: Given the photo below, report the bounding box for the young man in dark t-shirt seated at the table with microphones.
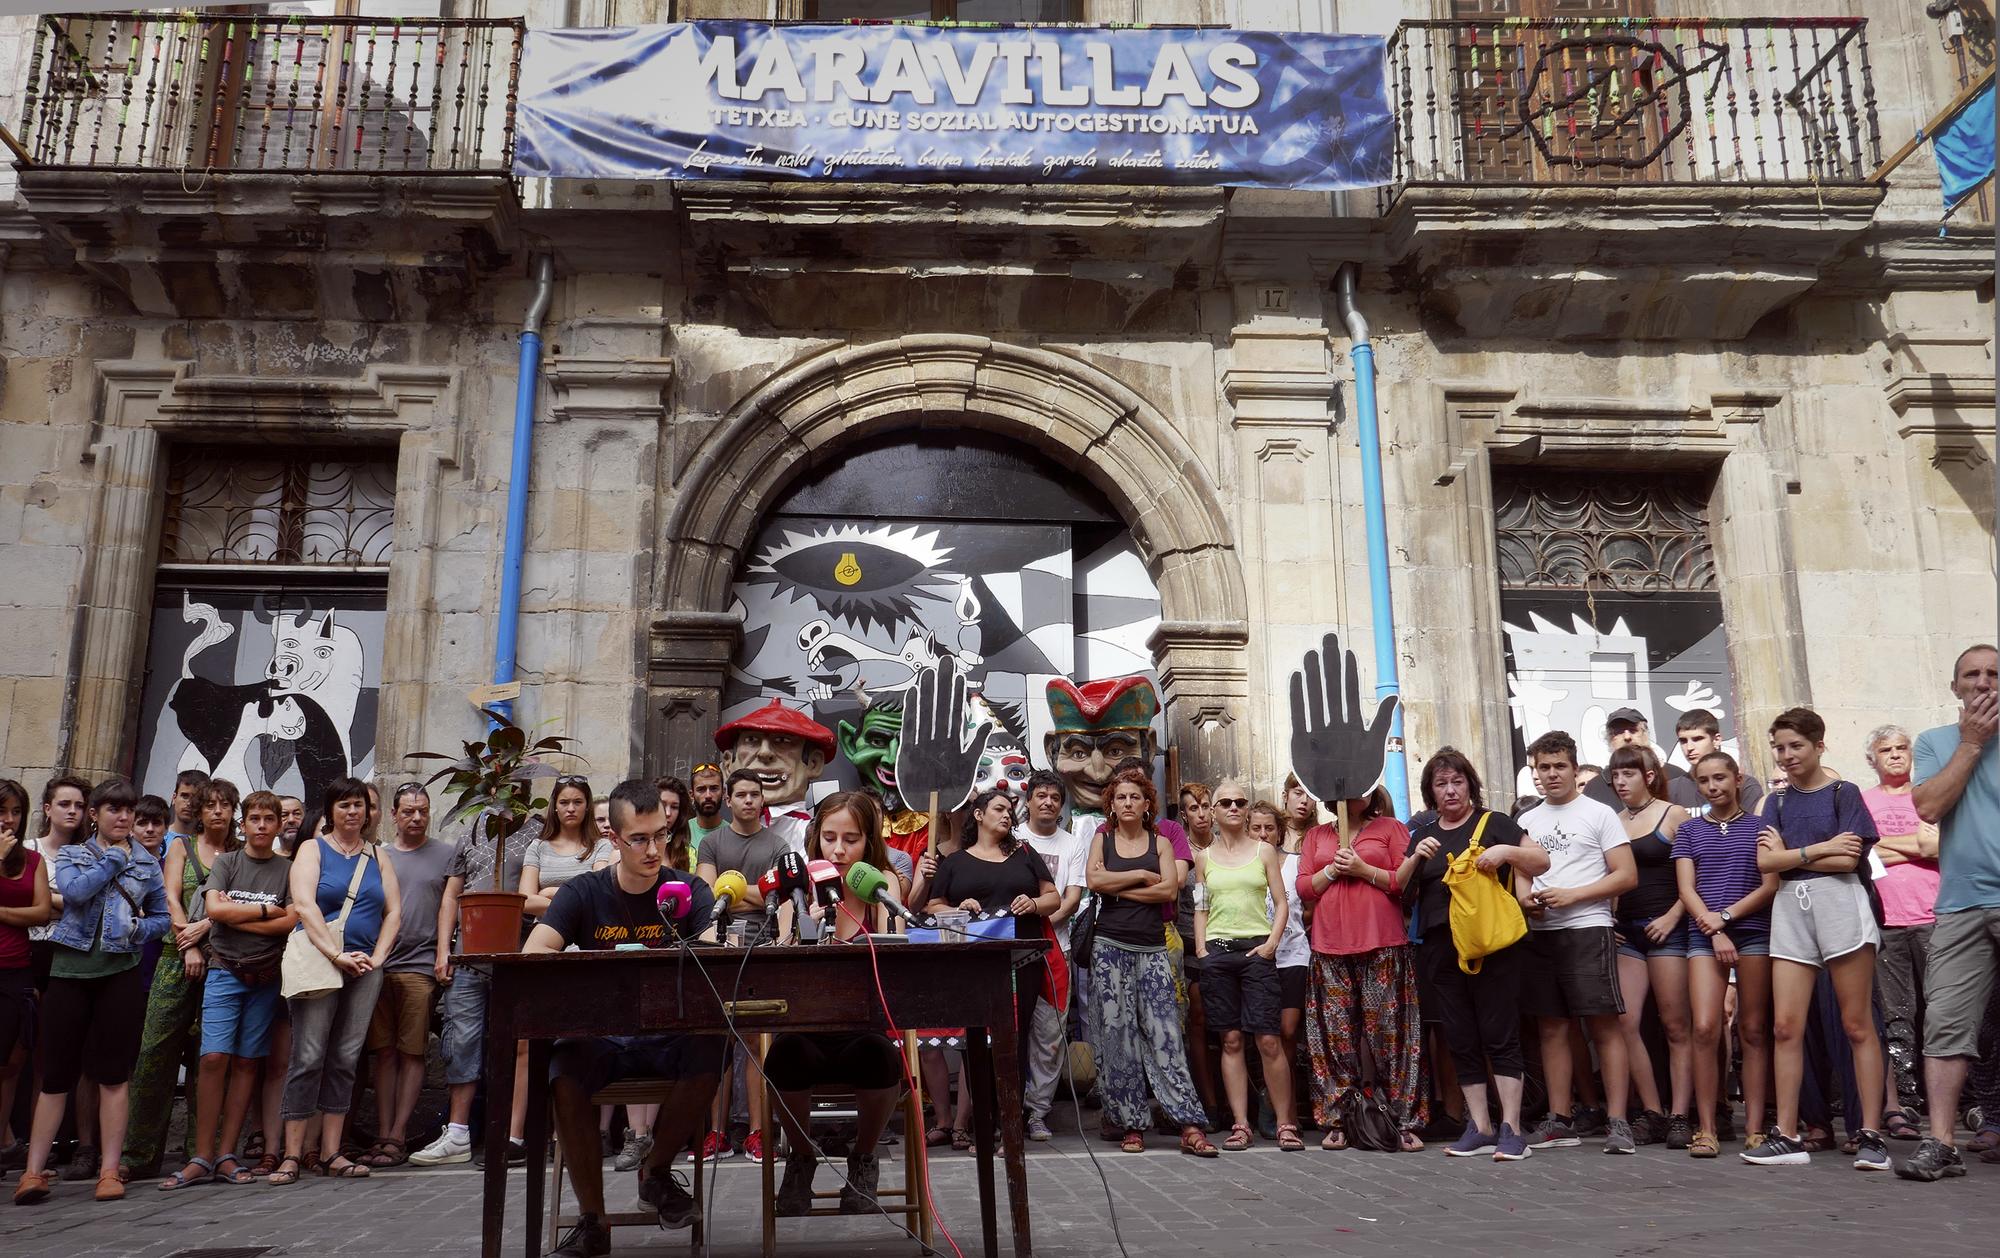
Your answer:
[524,778,722,1258]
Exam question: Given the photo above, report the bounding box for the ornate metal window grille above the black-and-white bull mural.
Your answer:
[160,446,396,568]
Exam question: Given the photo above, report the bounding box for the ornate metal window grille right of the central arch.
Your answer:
[1494,470,1718,594]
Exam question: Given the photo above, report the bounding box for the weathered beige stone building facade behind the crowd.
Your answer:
[0,0,1996,808]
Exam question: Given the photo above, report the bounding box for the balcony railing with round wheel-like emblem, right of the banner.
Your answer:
[1382,18,1882,206]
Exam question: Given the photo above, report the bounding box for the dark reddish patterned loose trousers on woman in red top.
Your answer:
[1306,944,1424,1130]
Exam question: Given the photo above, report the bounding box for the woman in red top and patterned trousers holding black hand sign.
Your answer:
[1298,786,1424,1152]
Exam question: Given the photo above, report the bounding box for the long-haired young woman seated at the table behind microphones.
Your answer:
[764,790,904,1218]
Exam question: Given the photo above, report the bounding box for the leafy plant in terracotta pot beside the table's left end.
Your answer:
[410,708,582,952]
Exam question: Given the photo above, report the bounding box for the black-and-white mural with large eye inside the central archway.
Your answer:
[722,516,1160,814]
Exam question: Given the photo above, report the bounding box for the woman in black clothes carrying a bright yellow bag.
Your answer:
[1410,748,1548,1162]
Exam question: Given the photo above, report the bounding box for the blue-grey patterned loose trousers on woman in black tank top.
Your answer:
[1090,934,1206,1132]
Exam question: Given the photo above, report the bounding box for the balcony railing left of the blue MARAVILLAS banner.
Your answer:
[16,12,522,176]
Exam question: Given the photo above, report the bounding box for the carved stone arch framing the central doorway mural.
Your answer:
[648,334,1248,776]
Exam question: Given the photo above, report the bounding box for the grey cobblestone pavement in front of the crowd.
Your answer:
[0,1134,2000,1258]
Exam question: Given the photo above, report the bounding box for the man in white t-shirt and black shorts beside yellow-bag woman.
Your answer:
[1520,730,1638,1154]
